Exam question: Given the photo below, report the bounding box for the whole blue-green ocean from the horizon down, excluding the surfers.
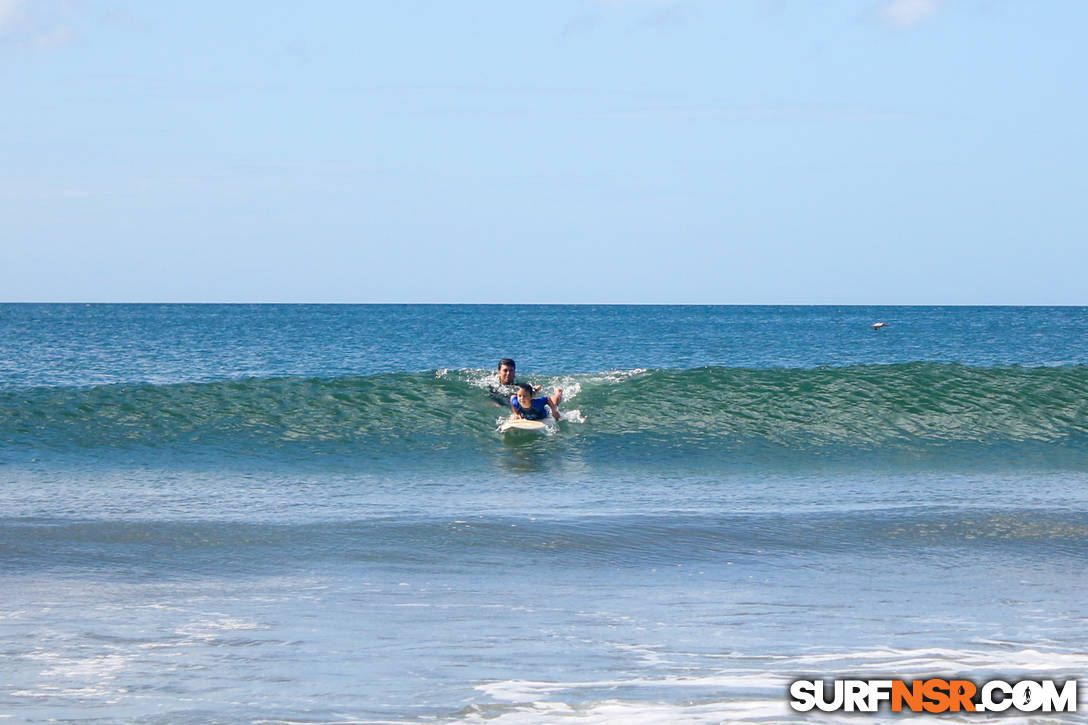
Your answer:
[0,304,1088,725]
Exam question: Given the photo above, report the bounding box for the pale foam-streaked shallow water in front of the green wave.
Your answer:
[6,470,1088,723]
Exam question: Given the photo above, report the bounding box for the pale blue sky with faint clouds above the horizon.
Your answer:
[0,0,1088,305]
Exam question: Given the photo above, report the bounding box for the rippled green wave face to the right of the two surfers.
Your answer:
[578,363,1088,446]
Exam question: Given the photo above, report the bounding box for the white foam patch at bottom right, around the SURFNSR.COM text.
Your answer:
[463,644,1088,725]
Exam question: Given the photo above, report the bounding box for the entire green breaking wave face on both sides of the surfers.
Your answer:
[6,363,1088,460]
